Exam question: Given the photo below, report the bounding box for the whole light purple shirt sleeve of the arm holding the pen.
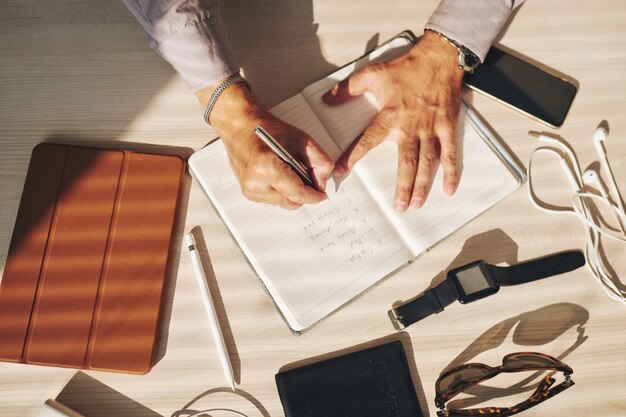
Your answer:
[123,0,239,91]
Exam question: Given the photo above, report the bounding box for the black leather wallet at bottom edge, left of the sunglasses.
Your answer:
[276,341,422,417]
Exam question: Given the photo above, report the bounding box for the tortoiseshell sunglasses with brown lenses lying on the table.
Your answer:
[435,352,574,417]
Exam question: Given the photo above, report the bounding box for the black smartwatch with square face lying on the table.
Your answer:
[388,251,585,330]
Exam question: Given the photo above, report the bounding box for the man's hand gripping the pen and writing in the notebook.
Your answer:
[196,84,334,210]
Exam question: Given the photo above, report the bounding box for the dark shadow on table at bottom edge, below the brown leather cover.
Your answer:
[56,372,162,417]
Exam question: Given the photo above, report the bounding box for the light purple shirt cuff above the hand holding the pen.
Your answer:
[151,15,239,92]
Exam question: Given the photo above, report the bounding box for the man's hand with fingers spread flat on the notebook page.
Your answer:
[323,31,463,212]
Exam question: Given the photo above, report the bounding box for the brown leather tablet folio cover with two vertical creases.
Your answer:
[0,144,185,373]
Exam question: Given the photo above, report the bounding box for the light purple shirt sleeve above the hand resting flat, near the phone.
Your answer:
[425,0,524,62]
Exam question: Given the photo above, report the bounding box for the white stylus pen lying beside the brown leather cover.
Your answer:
[185,233,235,391]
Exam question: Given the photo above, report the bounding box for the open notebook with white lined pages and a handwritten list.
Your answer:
[189,31,525,333]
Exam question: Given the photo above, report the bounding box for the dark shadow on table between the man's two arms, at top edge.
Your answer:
[220,0,338,107]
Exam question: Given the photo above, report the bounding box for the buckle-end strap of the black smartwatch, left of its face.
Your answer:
[389,278,459,330]
